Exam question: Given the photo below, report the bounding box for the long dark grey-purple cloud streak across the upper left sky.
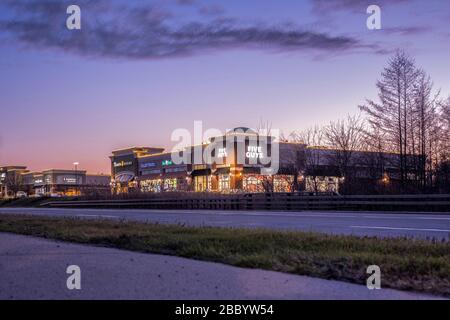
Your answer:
[0,0,382,59]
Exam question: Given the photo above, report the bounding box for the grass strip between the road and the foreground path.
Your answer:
[0,215,450,296]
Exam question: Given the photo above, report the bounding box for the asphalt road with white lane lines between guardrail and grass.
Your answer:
[0,208,450,240]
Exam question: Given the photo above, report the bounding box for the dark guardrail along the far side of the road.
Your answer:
[37,193,450,212]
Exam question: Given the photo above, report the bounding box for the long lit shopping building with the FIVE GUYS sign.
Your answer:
[110,128,412,193]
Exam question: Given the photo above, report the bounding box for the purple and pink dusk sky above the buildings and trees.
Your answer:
[0,0,450,173]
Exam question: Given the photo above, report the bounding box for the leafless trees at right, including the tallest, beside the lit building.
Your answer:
[286,51,450,193]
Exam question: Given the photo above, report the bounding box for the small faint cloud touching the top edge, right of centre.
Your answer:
[311,0,412,14]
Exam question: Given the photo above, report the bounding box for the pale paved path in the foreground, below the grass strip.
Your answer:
[0,233,437,300]
